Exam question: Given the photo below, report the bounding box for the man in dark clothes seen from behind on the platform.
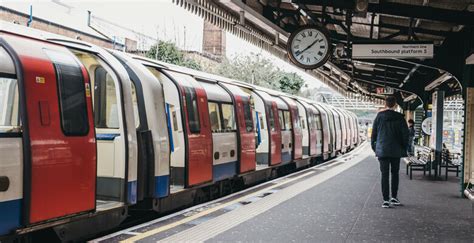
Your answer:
[371,96,408,208]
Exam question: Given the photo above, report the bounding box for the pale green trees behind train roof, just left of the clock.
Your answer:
[217,54,304,94]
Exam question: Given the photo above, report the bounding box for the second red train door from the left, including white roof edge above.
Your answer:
[166,71,213,187]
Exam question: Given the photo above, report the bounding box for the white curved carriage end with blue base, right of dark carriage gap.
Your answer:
[113,51,171,200]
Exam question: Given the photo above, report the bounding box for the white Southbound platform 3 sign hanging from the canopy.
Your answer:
[352,43,433,59]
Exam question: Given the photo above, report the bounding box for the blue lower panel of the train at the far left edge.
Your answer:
[0,199,22,235]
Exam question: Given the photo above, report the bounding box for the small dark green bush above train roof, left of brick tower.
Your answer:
[146,41,202,70]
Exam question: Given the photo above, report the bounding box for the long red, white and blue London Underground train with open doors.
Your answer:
[0,25,361,242]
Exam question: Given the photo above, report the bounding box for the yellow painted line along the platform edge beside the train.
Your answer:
[121,171,315,243]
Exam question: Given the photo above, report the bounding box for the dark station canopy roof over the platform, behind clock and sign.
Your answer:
[174,0,474,108]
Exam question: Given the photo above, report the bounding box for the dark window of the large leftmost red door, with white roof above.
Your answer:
[44,49,89,136]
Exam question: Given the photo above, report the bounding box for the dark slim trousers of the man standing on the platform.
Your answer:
[379,158,400,201]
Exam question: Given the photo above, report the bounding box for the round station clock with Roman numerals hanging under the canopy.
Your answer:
[288,27,330,69]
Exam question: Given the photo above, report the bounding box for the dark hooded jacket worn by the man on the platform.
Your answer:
[371,110,408,158]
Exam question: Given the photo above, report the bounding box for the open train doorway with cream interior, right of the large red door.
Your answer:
[71,49,140,207]
